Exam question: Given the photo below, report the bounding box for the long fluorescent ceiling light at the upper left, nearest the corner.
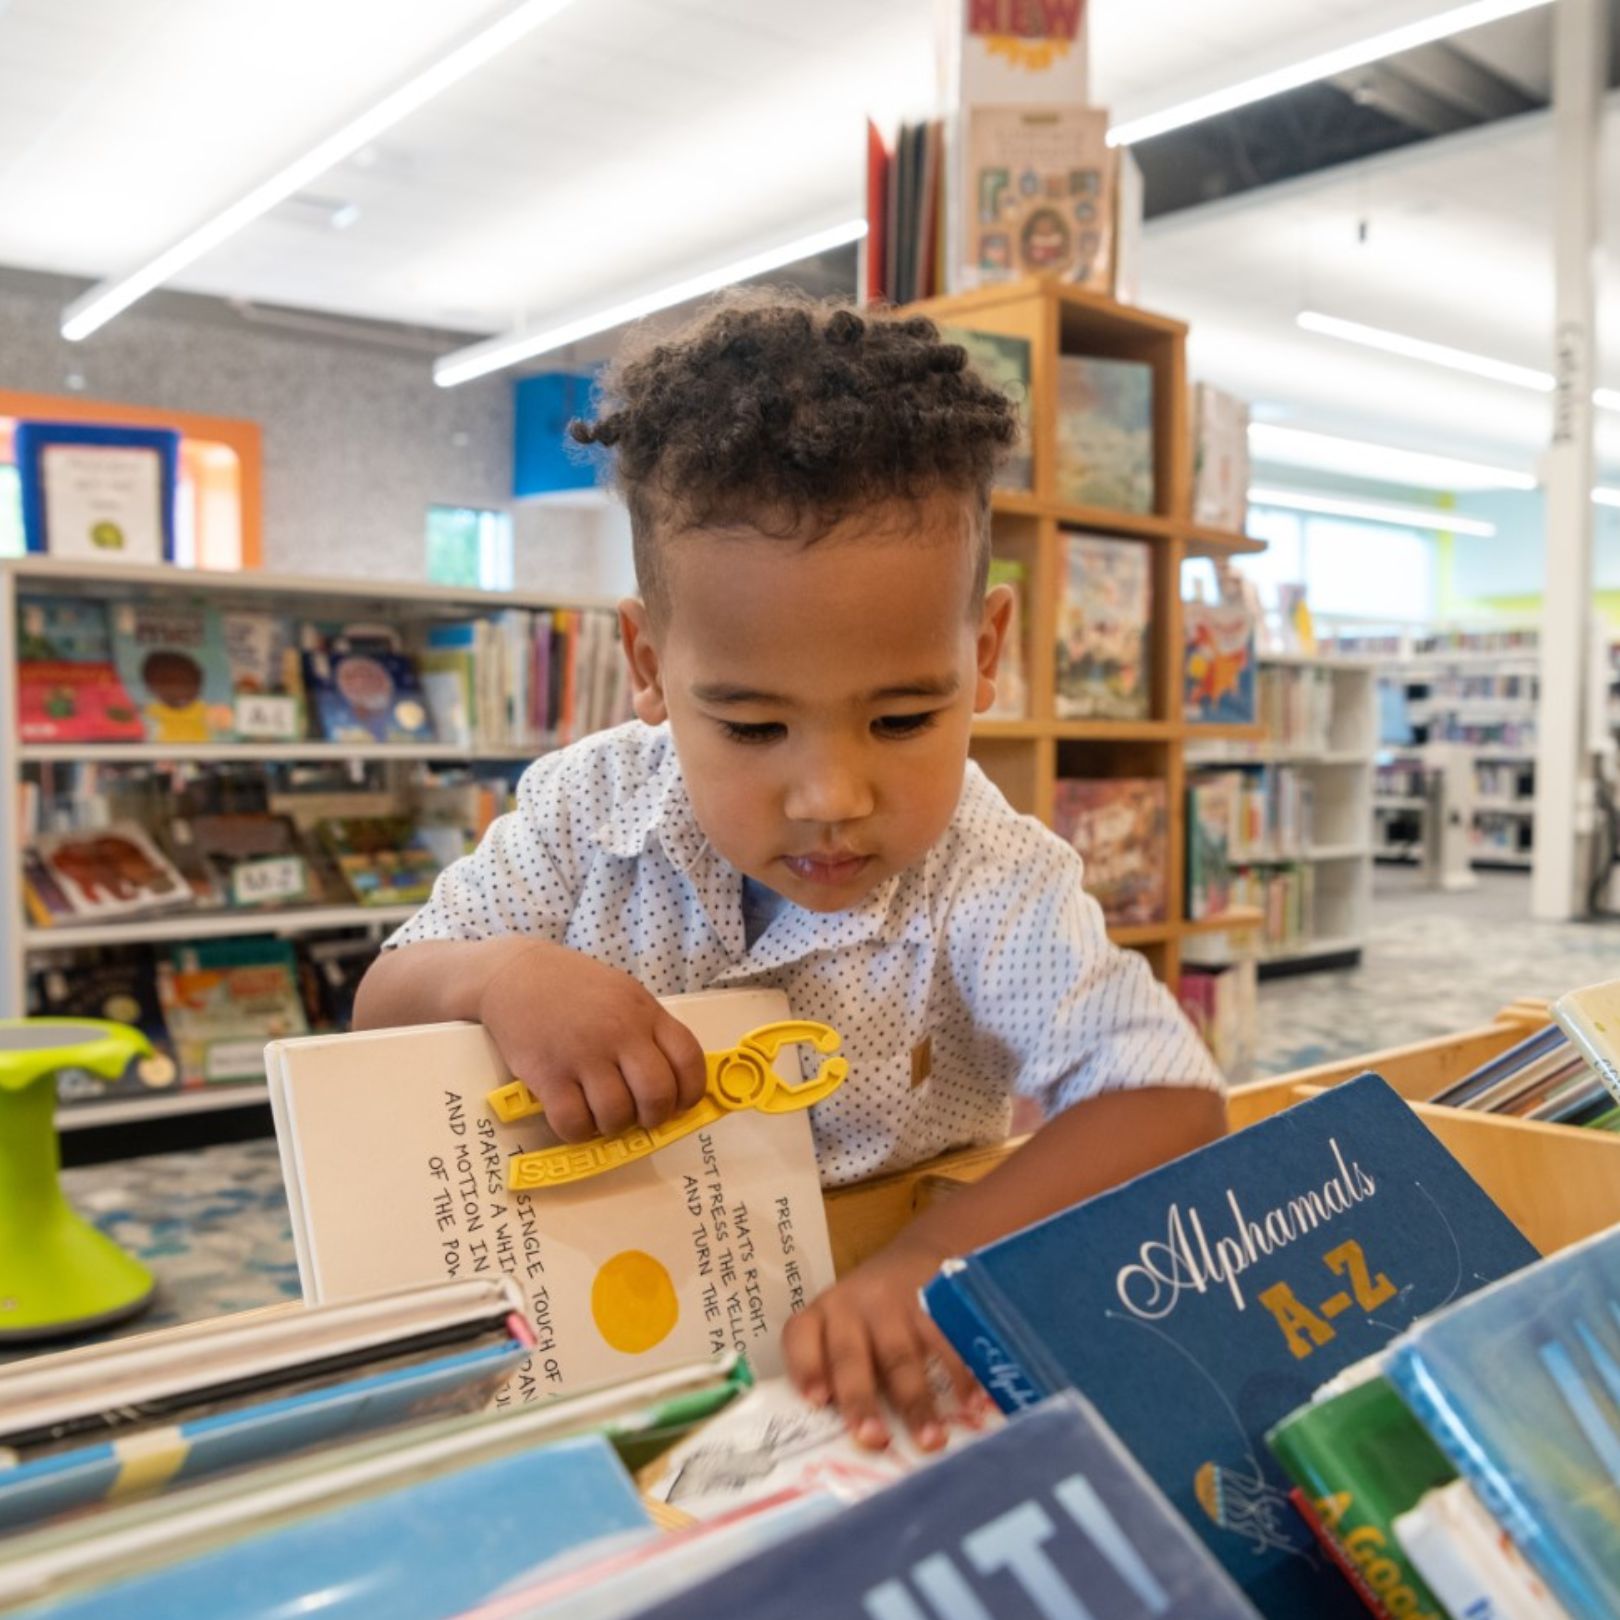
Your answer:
[62,0,583,343]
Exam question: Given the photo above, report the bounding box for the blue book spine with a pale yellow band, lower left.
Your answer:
[0,1338,530,1531]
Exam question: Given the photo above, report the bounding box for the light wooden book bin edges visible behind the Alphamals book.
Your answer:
[826,1001,1620,1272]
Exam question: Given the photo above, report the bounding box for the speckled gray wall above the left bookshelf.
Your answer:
[0,271,627,595]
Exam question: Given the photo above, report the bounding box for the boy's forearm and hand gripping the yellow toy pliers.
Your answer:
[355,935,706,1142]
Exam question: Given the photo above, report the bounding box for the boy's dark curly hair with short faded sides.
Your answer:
[569,288,1019,611]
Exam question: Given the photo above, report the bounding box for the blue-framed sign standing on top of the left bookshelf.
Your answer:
[15,421,180,562]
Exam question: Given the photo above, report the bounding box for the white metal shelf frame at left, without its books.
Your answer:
[0,556,614,1129]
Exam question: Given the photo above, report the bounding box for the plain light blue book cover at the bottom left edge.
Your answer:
[21,1435,650,1620]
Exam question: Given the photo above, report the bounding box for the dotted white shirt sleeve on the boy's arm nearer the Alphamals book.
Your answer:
[951,829,1223,1118]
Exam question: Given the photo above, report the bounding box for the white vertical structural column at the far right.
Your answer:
[1531,0,1609,920]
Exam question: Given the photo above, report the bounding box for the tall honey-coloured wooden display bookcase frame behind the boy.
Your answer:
[912,279,1264,985]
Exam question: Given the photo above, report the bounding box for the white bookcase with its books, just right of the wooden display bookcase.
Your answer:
[1184,653,1377,975]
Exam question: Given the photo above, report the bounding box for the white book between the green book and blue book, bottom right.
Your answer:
[1395,1479,1568,1620]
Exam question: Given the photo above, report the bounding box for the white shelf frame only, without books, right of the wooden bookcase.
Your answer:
[1187,653,1377,974]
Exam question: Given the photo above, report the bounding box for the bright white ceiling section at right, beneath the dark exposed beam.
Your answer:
[1142,100,1620,471]
